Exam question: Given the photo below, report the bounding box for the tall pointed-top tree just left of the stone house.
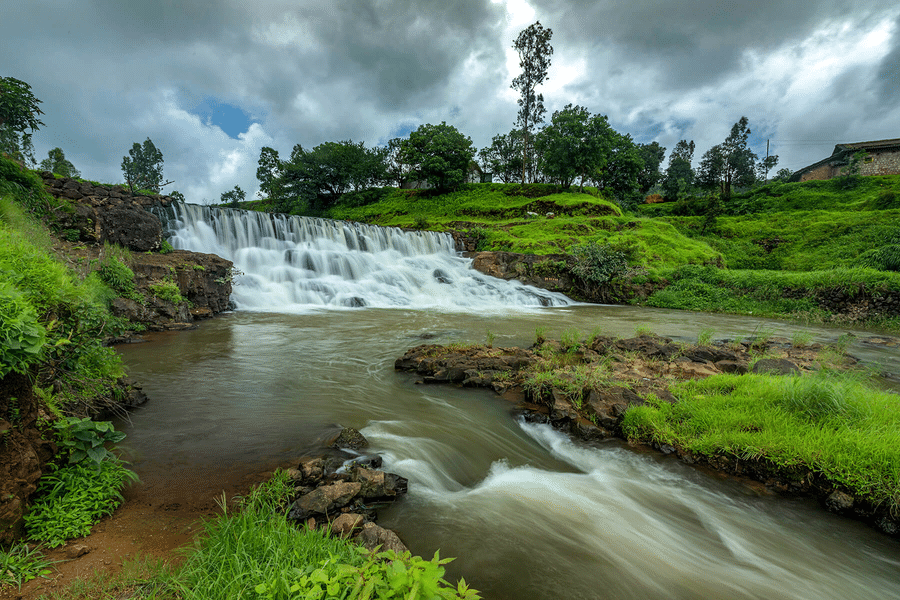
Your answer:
[697,117,756,202]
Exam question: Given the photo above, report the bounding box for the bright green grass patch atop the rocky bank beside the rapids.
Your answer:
[623,370,900,510]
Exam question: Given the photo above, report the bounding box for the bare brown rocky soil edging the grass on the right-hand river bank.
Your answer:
[395,334,900,536]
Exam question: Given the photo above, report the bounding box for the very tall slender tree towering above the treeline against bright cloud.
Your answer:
[510,21,553,183]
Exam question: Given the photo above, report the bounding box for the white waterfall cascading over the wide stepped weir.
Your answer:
[157,203,572,312]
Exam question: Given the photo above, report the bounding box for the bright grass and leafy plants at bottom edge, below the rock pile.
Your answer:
[172,472,479,600]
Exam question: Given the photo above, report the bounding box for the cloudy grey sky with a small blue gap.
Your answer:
[0,0,900,202]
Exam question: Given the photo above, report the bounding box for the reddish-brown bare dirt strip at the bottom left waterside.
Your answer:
[0,464,280,600]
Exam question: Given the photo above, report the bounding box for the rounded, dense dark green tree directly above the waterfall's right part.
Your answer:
[400,121,475,191]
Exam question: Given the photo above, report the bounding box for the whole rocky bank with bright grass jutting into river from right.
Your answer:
[395,332,900,536]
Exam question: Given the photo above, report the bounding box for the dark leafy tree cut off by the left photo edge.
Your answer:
[0,77,44,164]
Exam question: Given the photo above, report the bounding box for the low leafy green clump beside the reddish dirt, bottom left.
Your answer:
[25,460,137,548]
